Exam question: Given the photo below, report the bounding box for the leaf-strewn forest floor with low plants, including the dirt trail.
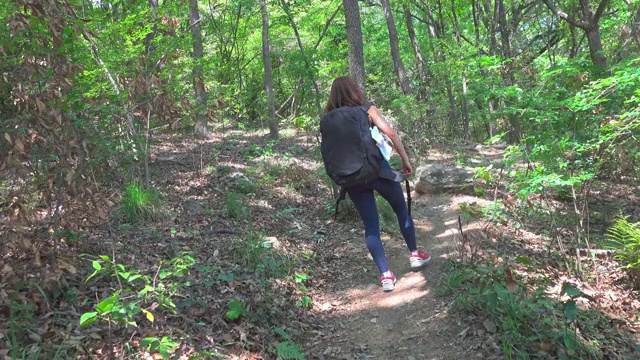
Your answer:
[0,131,640,360]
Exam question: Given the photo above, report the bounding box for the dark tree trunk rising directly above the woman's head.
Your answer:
[342,0,366,92]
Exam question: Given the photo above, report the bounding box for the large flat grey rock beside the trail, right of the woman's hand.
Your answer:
[414,164,473,194]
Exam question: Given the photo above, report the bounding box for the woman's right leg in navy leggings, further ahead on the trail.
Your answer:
[372,178,418,252]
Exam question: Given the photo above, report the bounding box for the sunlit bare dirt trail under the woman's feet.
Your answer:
[308,195,488,360]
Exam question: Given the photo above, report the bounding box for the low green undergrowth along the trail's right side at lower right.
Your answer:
[438,257,600,359]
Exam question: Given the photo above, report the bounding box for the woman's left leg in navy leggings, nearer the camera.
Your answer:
[347,187,389,274]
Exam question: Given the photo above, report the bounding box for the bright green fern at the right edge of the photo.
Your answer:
[607,217,640,287]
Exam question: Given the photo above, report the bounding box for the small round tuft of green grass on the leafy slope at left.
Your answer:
[122,183,160,224]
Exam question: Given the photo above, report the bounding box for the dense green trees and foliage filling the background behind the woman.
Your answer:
[0,0,640,358]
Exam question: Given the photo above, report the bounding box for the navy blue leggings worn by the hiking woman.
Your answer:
[347,178,418,273]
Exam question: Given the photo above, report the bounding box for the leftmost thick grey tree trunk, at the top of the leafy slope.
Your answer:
[189,0,209,137]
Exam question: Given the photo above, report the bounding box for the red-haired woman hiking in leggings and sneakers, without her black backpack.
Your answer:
[325,76,431,291]
